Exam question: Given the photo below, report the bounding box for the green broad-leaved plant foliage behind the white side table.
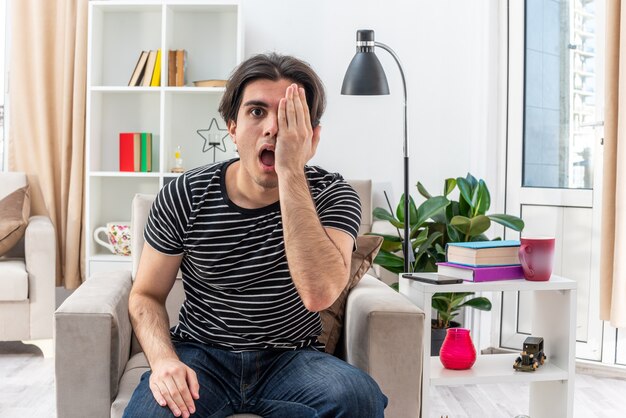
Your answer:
[373,173,524,355]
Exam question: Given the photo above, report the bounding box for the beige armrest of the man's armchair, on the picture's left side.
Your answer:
[54,271,132,418]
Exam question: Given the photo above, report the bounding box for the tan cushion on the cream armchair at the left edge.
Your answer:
[0,185,30,256]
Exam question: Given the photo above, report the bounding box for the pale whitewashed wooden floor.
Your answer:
[0,342,626,418]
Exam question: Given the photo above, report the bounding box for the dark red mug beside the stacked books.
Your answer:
[519,237,555,282]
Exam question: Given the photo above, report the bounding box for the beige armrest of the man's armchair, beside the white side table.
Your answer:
[344,275,424,417]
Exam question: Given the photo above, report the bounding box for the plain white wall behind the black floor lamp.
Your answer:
[242,0,505,209]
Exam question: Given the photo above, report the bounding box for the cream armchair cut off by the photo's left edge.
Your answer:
[0,172,56,354]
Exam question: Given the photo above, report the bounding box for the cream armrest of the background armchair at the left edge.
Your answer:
[24,216,56,340]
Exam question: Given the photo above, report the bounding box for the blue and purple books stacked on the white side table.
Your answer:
[437,240,524,282]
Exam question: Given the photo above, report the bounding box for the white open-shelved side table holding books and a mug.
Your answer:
[400,273,576,418]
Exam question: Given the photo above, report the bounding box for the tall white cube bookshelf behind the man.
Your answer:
[85,0,243,275]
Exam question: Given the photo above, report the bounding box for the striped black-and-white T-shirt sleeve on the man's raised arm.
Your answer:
[315,177,361,241]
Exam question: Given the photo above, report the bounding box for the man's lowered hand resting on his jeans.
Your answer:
[150,359,200,418]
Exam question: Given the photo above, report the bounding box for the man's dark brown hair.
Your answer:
[219,52,326,128]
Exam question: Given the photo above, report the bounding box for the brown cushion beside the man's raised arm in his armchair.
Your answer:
[319,235,383,354]
